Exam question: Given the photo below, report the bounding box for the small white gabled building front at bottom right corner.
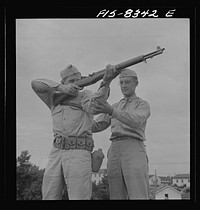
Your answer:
[154,185,182,200]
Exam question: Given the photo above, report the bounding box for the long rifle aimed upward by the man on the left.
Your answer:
[54,46,165,105]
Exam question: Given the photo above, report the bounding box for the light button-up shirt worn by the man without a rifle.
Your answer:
[93,95,150,141]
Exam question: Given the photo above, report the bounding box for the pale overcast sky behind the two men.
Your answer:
[16,18,190,176]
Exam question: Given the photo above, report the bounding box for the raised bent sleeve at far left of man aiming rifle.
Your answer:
[31,79,60,109]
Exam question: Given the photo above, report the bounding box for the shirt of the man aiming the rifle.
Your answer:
[32,79,109,137]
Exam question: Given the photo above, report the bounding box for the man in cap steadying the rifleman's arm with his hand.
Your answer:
[92,66,150,199]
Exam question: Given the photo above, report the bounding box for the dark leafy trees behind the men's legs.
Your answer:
[16,150,109,200]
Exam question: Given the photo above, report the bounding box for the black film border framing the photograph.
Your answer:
[2,2,198,206]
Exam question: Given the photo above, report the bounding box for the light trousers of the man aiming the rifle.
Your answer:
[42,147,92,200]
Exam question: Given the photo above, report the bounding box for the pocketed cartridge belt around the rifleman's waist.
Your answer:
[53,134,94,152]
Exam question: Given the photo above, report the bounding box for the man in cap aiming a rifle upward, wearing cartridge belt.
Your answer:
[31,65,114,200]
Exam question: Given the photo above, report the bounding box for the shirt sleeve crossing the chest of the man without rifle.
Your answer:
[112,101,150,128]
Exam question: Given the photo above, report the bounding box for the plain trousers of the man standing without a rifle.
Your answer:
[107,139,149,200]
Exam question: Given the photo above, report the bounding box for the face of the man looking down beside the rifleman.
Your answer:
[119,77,138,97]
